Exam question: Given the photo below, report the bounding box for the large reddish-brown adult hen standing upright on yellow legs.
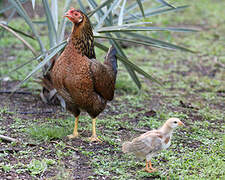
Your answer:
[50,8,117,141]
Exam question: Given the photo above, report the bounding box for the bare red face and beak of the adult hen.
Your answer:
[64,8,85,25]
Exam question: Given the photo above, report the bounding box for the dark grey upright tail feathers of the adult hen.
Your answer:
[104,46,117,75]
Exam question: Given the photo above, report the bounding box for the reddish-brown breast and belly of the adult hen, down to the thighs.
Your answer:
[51,44,106,118]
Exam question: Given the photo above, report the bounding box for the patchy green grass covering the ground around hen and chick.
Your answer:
[0,0,225,180]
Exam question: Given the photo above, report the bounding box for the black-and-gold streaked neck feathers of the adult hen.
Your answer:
[69,16,96,59]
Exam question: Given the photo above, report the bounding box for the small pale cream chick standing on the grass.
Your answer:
[122,118,184,173]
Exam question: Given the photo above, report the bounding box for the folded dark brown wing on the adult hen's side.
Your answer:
[90,59,116,100]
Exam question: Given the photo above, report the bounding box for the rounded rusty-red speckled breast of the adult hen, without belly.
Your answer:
[51,44,93,105]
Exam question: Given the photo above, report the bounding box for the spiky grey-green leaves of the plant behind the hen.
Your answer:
[0,0,194,101]
